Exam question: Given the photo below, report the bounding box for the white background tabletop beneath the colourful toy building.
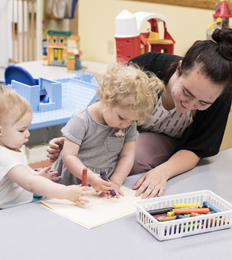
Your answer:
[17,60,108,79]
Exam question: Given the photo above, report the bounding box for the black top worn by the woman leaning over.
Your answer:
[130,52,231,158]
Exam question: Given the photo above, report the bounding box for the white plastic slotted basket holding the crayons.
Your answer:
[135,190,232,241]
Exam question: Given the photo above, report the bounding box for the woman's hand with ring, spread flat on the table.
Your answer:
[133,166,168,199]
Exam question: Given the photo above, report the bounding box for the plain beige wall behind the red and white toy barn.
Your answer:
[78,0,218,63]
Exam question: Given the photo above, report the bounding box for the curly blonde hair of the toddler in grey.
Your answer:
[97,63,164,125]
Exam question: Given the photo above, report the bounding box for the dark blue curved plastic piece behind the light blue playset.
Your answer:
[5,65,39,86]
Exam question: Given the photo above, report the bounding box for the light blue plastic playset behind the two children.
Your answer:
[10,72,98,130]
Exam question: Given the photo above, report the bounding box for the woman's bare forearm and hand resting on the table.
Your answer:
[133,150,200,199]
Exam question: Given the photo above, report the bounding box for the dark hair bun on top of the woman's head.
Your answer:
[212,28,232,61]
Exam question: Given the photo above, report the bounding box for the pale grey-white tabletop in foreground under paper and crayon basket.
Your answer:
[0,149,232,260]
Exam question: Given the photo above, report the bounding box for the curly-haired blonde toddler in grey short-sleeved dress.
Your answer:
[55,64,164,198]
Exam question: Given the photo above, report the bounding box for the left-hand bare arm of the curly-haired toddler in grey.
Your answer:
[62,138,112,192]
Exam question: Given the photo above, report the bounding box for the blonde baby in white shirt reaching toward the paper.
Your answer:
[0,86,93,209]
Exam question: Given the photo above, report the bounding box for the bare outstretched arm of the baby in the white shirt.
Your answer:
[6,165,94,206]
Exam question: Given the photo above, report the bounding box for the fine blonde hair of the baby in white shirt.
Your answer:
[0,86,32,125]
